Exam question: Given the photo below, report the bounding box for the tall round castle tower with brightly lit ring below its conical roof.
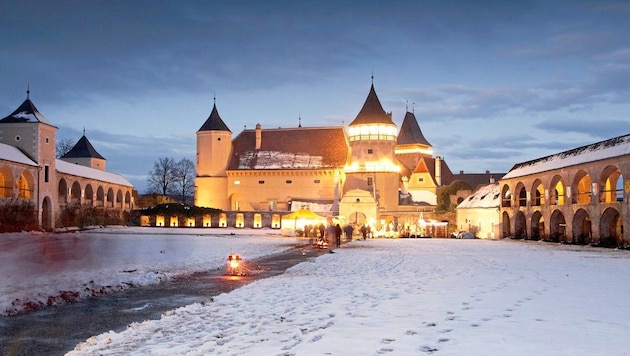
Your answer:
[340,84,400,218]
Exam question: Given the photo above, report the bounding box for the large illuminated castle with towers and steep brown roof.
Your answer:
[195,84,482,234]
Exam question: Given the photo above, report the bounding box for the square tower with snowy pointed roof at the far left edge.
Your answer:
[0,91,57,230]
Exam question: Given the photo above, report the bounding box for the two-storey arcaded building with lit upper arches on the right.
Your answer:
[499,135,630,246]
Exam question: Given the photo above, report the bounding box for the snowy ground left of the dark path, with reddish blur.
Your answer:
[0,227,304,315]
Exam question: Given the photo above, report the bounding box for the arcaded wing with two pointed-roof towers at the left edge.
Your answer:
[0,91,134,230]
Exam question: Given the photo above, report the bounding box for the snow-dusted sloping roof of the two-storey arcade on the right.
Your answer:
[502,134,630,179]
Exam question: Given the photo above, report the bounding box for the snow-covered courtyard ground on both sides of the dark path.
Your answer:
[0,230,630,355]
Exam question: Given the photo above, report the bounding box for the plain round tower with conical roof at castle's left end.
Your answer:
[195,102,232,210]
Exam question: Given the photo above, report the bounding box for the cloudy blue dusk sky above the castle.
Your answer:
[0,0,630,193]
